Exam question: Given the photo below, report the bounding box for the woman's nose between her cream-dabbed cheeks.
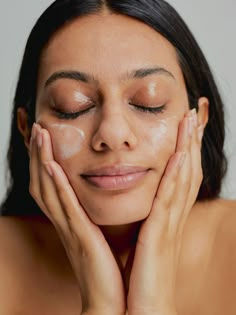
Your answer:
[91,112,137,152]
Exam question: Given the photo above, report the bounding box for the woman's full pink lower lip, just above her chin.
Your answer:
[83,171,148,190]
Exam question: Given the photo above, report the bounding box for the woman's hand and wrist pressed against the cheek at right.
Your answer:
[127,110,203,315]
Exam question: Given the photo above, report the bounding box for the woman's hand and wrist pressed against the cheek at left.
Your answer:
[30,124,126,315]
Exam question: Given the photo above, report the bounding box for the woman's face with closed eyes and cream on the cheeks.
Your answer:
[36,13,188,225]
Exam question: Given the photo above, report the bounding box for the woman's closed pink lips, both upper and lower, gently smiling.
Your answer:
[81,166,148,190]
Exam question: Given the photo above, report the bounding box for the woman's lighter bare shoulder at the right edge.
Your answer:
[177,199,236,315]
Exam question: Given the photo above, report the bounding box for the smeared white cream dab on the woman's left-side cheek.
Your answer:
[49,124,85,160]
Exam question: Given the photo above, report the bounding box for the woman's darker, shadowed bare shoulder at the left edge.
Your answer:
[0,217,78,315]
